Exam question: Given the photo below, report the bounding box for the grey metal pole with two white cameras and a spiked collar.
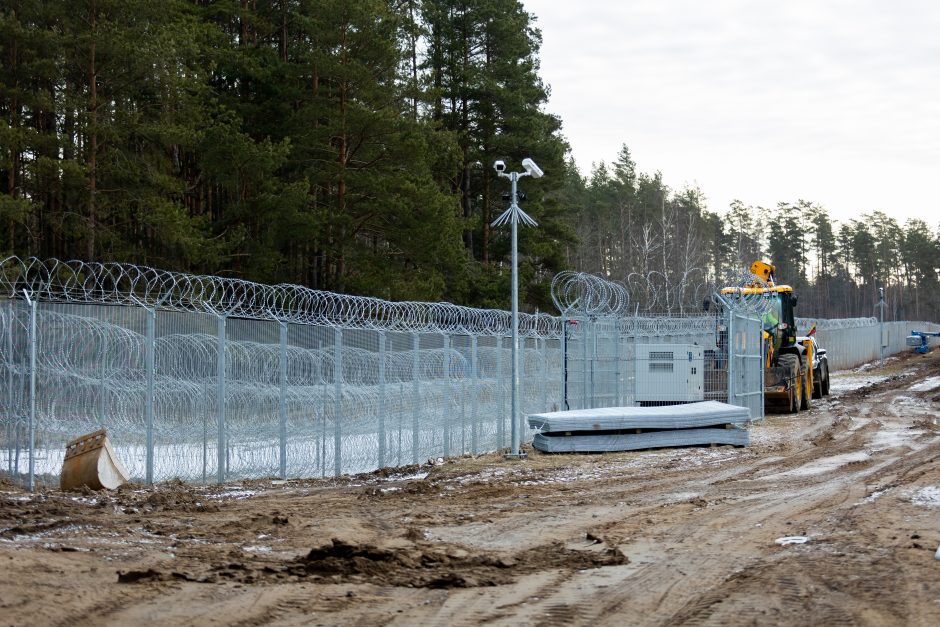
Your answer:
[492,158,543,459]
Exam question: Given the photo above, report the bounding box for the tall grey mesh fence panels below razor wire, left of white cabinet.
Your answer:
[0,299,559,482]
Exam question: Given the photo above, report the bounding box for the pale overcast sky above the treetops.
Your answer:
[523,0,940,228]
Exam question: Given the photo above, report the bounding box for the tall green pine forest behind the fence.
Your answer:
[0,0,940,320]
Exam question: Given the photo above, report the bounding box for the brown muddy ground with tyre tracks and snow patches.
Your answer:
[0,351,940,625]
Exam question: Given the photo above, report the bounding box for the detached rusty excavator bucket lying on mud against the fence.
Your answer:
[59,429,127,490]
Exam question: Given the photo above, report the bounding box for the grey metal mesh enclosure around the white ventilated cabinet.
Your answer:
[561,310,763,419]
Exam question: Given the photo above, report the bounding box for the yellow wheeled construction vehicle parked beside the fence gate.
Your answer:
[721,261,816,413]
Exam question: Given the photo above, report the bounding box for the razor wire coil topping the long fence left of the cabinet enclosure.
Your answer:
[0,257,561,339]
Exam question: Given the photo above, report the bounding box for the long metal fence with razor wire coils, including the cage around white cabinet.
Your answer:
[0,257,920,485]
